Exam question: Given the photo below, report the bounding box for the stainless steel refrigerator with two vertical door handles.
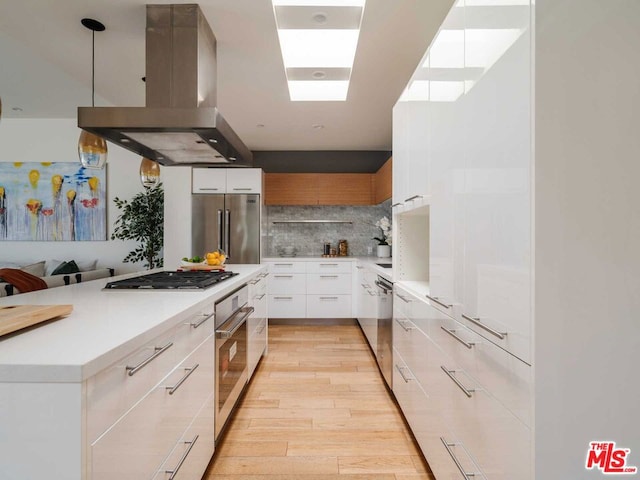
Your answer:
[191,194,260,263]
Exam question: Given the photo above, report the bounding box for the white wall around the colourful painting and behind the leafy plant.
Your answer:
[0,119,154,273]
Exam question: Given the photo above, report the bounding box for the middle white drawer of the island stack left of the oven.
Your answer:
[90,335,215,480]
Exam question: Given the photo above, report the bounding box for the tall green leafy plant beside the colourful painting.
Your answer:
[111,183,164,269]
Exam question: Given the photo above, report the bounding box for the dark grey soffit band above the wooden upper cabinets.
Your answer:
[253,150,391,173]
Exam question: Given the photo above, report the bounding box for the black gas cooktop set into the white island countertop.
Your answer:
[104,271,237,290]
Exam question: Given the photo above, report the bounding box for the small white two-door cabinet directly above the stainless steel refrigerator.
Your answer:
[192,168,262,193]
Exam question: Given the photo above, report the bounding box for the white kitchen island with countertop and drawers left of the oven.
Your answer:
[0,265,265,480]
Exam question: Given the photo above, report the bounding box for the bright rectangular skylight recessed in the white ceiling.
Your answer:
[272,0,365,101]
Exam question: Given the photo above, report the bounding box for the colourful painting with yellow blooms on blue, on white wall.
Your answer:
[0,162,107,241]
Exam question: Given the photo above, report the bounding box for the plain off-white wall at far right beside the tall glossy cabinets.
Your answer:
[535,0,640,479]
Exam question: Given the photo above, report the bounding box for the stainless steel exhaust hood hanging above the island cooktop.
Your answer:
[78,4,253,167]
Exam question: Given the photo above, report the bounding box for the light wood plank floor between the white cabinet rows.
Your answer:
[203,325,435,480]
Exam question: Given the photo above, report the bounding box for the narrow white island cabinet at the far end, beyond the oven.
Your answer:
[247,272,268,378]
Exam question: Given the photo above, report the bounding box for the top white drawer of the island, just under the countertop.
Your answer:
[87,305,214,441]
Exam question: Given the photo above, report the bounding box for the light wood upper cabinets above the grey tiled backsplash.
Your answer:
[264,160,391,205]
